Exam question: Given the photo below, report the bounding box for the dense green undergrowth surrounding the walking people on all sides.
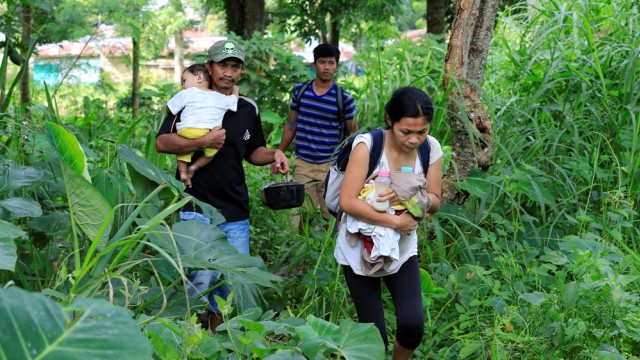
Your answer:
[0,0,640,359]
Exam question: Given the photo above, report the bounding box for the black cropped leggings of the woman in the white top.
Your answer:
[342,256,424,349]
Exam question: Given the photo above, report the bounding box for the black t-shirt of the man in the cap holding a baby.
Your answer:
[158,97,266,221]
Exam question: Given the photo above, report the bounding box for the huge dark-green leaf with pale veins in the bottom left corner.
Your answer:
[0,287,152,360]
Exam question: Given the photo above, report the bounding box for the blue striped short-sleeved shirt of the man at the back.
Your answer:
[290,83,356,164]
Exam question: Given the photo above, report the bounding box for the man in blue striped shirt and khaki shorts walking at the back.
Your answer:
[278,44,358,228]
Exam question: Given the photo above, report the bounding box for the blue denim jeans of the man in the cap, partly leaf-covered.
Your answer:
[180,211,249,314]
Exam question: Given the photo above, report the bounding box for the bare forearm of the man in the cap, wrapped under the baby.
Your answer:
[156,126,225,154]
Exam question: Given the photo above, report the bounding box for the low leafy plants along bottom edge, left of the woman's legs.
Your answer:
[145,302,384,359]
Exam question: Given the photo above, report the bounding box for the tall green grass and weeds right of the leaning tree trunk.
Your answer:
[412,1,640,359]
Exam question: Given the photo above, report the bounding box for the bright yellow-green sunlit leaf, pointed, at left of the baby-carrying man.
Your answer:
[45,122,91,182]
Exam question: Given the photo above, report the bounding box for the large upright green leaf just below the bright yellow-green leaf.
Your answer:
[61,162,113,248]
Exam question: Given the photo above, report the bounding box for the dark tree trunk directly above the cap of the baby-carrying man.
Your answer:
[224,0,265,40]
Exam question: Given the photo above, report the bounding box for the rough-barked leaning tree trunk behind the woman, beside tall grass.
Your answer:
[442,0,499,204]
